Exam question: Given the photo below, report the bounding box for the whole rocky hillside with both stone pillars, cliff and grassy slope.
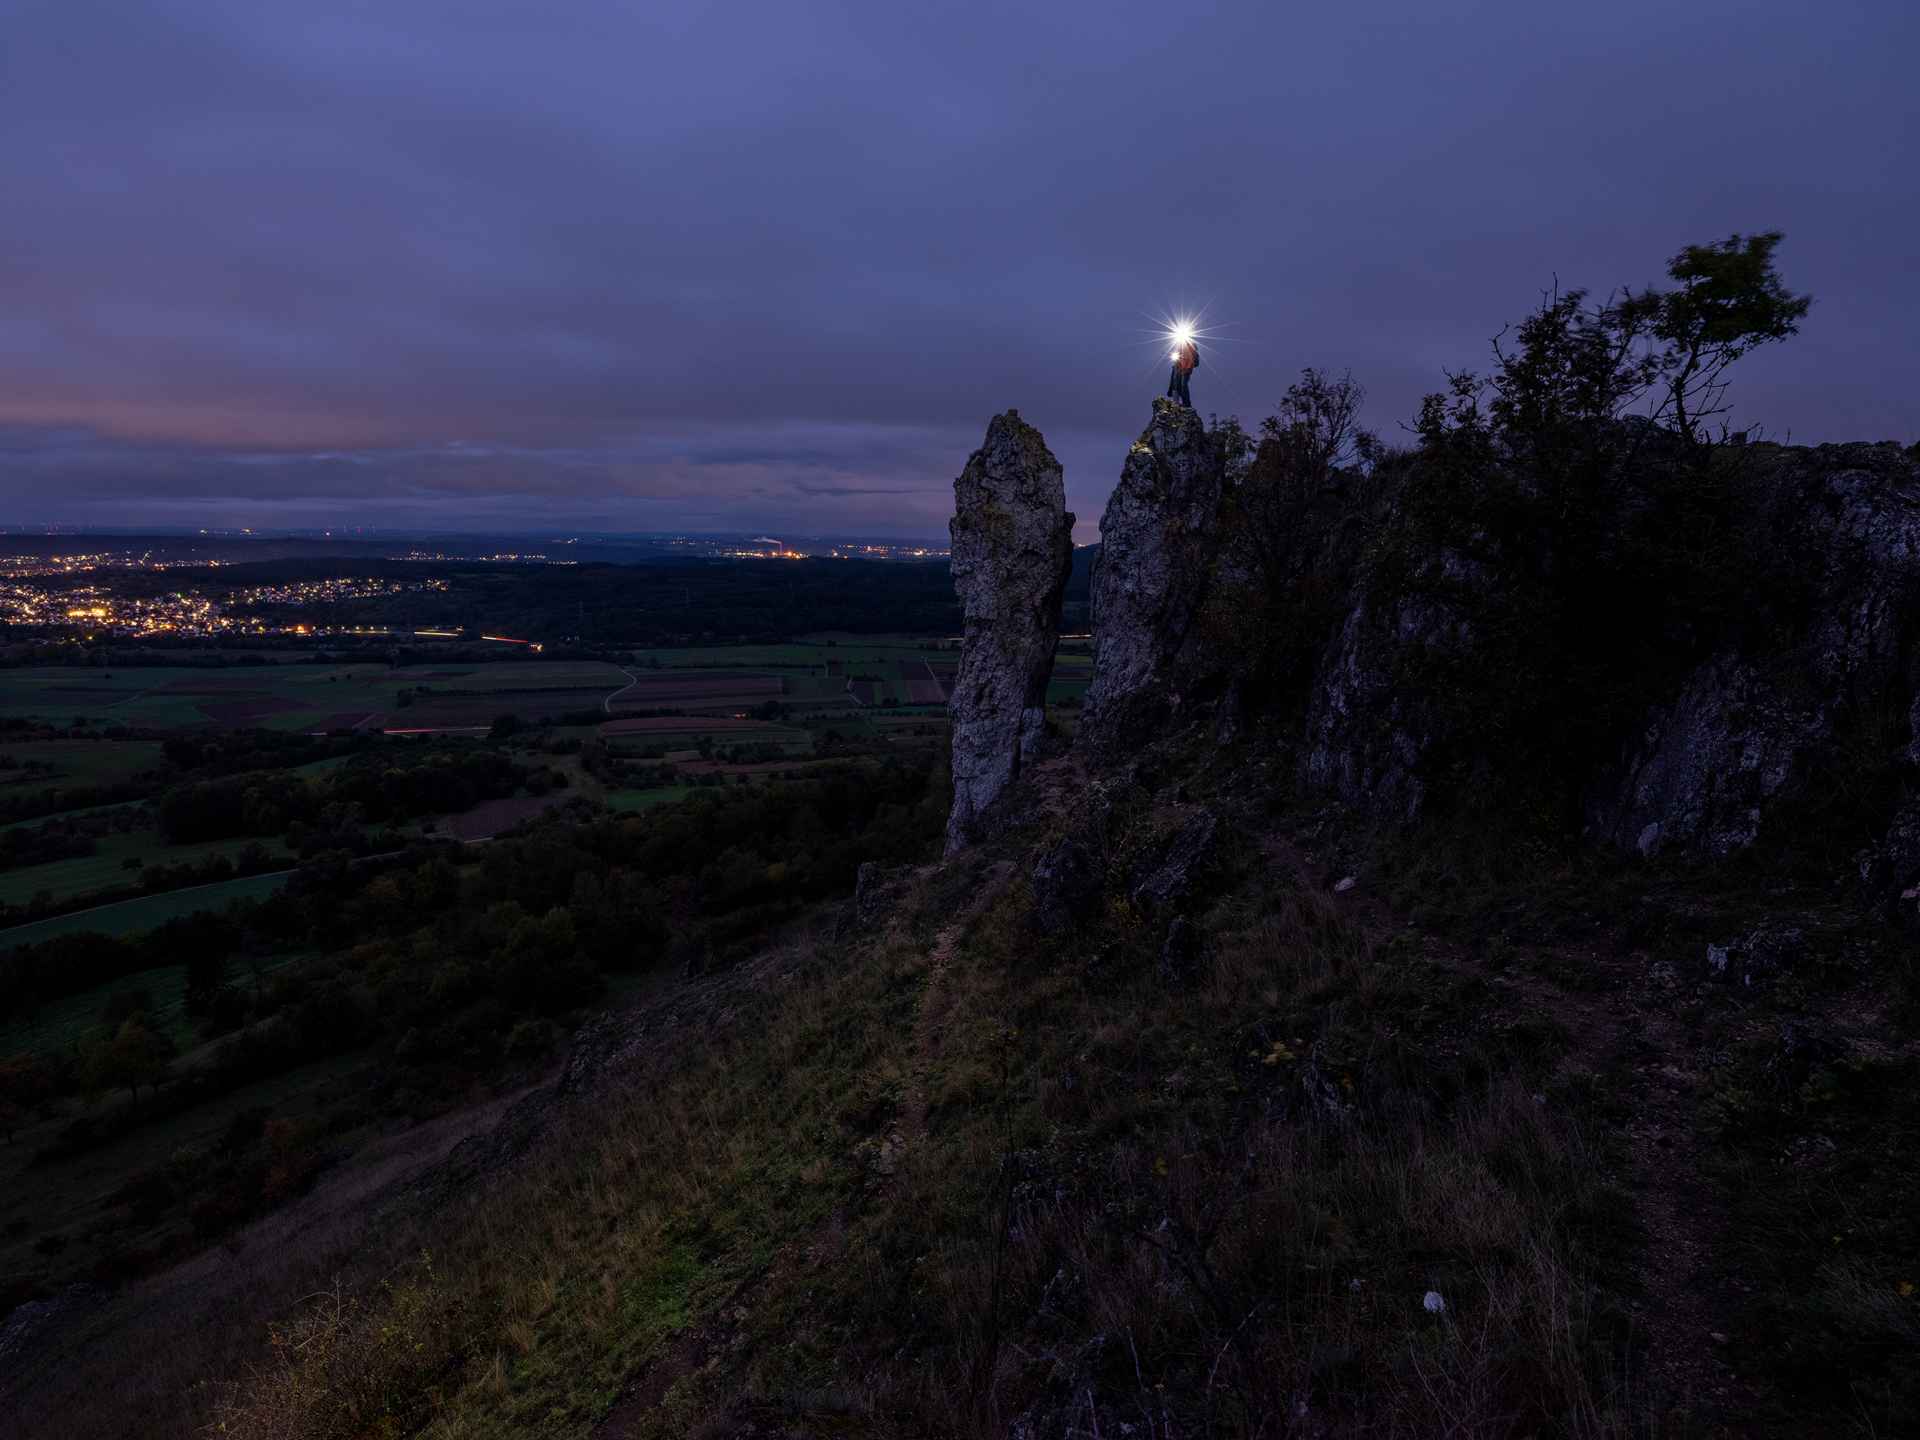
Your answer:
[15,385,1920,1440]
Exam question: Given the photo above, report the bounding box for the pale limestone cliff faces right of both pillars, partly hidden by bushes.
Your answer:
[1298,445,1920,889]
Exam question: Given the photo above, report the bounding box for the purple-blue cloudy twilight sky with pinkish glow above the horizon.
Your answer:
[0,0,1920,540]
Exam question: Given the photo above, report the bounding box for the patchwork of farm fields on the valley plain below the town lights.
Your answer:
[0,636,960,947]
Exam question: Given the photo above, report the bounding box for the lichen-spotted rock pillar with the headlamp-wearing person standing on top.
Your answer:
[1079,399,1225,758]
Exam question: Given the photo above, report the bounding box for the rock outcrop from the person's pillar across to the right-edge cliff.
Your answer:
[1079,391,1920,879]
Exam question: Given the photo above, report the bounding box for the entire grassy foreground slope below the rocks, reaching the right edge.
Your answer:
[18,755,1920,1440]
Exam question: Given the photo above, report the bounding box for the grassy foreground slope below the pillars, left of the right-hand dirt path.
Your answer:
[198,756,1651,1436]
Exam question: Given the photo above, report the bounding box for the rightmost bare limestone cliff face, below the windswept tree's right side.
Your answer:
[1590,445,1920,864]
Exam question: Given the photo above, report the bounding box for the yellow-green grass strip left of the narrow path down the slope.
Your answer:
[194,913,913,1440]
